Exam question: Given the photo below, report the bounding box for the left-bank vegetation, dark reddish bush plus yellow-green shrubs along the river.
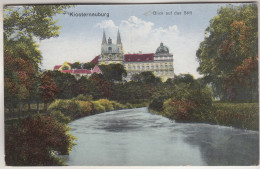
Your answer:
[5,95,147,166]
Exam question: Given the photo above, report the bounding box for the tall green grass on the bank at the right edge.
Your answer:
[212,103,259,130]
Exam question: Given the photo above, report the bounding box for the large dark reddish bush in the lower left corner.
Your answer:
[5,116,75,166]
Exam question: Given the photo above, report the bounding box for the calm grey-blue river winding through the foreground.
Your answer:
[67,108,259,166]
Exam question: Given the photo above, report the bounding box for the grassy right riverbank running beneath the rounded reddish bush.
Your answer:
[149,103,259,131]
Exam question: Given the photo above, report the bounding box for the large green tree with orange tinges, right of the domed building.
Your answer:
[196,4,258,100]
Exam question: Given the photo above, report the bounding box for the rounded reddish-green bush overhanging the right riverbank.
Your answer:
[163,87,212,122]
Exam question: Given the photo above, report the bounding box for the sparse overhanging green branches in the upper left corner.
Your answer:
[4,5,71,40]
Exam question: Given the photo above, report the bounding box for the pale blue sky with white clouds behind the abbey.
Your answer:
[37,3,243,78]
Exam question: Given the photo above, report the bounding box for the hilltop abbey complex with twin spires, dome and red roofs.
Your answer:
[54,31,174,81]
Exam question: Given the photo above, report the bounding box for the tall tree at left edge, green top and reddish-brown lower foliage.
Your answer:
[3,5,70,112]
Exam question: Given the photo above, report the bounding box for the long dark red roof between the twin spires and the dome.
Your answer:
[125,53,154,62]
